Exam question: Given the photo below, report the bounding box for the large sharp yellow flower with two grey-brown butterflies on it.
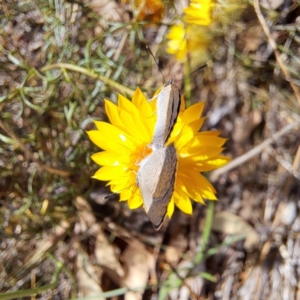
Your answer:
[87,89,230,217]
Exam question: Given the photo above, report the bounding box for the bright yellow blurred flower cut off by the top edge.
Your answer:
[183,0,215,26]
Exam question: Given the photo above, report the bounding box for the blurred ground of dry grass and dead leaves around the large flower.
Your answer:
[0,0,300,300]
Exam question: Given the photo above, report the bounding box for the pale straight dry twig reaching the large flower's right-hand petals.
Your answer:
[210,120,300,182]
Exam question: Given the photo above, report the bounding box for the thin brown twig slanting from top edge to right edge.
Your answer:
[253,0,300,105]
